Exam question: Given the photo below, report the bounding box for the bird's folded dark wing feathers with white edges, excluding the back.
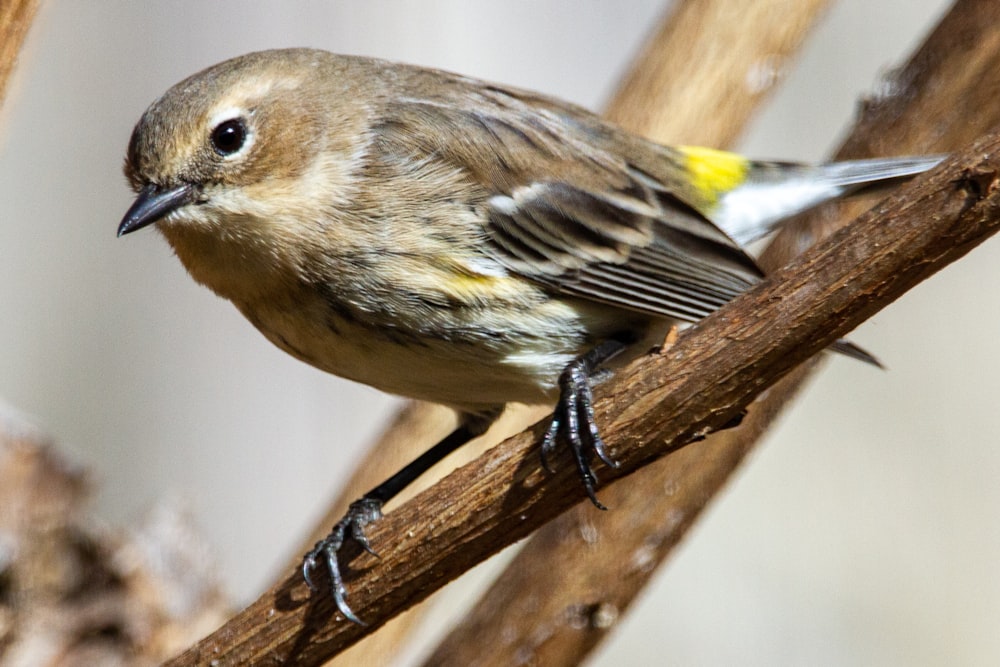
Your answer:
[487,176,761,321]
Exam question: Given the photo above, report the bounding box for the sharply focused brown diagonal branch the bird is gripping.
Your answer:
[162,130,1000,666]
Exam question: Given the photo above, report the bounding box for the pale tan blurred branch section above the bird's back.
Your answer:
[605,0,830,146]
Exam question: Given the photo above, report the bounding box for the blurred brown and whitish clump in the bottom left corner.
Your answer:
[0,403,228,665]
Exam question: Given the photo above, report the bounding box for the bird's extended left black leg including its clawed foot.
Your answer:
[302,418,499,625]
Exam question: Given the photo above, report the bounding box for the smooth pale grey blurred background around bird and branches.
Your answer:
[0,0,1000,665]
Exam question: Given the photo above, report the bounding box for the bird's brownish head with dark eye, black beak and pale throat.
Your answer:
[118,49,372,292]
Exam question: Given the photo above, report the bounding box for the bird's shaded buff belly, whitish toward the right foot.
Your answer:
[240,299,589,410]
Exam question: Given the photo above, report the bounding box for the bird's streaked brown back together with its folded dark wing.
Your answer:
[376,81,763,321]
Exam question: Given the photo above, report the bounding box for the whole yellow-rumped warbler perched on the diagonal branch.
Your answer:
[118,49,939,621]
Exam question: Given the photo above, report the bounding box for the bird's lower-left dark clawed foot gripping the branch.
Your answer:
[302,498,382,625]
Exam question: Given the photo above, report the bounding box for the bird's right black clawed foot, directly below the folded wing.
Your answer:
[542,338,628,509]
